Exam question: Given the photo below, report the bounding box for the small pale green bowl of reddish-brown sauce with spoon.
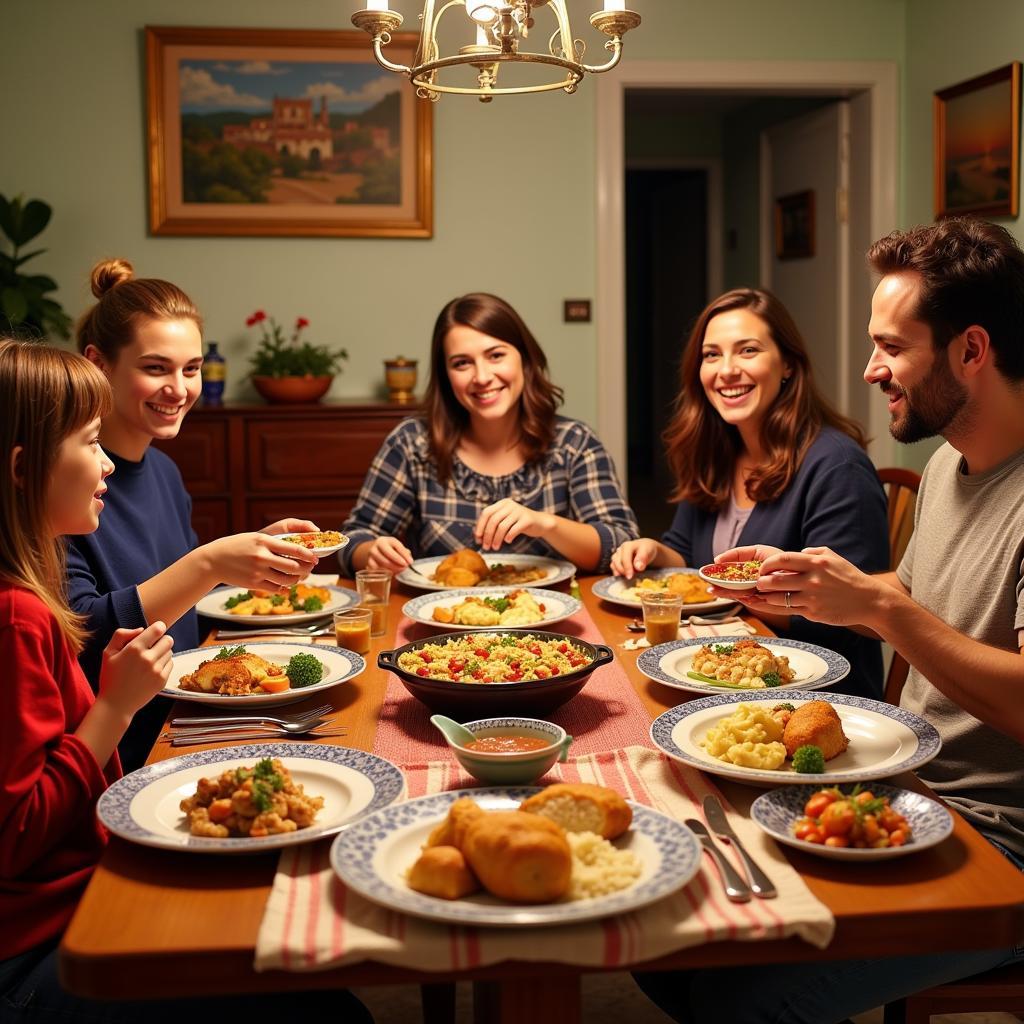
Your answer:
[434,718,572,785]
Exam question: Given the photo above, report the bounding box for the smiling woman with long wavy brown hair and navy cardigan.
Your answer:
[611,288,889,698]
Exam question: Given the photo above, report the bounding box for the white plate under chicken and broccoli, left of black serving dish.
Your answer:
[162,640,367,711]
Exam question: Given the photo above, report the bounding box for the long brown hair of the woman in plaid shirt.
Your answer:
[423,292,562,484]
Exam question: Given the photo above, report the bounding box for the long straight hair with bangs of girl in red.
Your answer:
[0,340,111,652]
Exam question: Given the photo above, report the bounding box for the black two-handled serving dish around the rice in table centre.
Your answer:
[377,629,614,722]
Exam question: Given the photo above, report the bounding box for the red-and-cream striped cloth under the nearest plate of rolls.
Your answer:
[255,745,835,971]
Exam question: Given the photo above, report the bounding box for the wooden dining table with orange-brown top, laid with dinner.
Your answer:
[59,578,1024,1024]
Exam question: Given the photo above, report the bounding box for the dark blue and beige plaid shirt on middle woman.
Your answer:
[339,417,637,574]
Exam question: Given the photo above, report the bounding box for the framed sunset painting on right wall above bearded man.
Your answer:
[934,60,1021,217]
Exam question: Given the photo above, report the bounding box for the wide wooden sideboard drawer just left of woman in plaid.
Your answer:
[246,419,395,496]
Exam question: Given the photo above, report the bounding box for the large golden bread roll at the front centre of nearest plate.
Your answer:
[462,811,572,903]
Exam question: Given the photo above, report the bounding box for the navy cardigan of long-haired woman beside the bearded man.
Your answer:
[662,428,889,700]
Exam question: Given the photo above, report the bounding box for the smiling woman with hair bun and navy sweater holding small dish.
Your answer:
[68,259,316,768]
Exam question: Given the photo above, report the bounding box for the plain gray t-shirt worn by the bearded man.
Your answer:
[896,444,1024,856]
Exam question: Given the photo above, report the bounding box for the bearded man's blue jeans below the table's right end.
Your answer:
[634,841,1024,1024]
